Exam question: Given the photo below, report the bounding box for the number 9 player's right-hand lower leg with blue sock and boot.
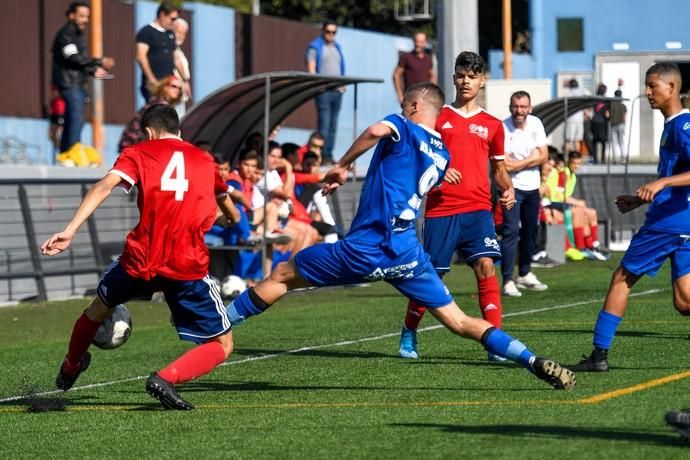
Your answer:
[430,302,576,390]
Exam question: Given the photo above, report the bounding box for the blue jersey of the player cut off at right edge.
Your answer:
[645,110,690,234]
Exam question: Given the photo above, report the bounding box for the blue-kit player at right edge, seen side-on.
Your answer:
[570,63,690,372]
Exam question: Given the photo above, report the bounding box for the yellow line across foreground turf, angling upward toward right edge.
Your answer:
[5,371,690,414]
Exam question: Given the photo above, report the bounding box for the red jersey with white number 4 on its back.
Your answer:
[109,137,228,281]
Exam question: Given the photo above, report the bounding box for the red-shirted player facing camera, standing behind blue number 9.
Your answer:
[399,51,515,361]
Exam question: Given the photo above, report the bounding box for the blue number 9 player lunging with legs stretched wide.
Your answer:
[228,83,575,389]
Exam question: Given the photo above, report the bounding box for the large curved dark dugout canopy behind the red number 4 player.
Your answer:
[181,72,383,160]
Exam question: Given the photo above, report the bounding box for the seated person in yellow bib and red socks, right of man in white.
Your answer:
[546,152,608,260]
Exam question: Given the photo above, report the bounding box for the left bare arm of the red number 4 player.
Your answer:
[41,174,122,256]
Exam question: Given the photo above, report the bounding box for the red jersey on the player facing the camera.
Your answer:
[426,105,505,217]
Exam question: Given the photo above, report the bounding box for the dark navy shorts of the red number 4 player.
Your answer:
[97,260,231,343]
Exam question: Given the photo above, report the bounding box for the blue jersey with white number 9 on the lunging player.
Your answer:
[346,114,450,255]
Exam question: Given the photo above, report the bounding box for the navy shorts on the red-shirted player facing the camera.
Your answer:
[424,211,501,273]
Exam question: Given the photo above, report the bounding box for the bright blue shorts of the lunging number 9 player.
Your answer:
[295,239,453,308]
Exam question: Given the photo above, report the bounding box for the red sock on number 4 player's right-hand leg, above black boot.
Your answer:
[158,342,225,385]
